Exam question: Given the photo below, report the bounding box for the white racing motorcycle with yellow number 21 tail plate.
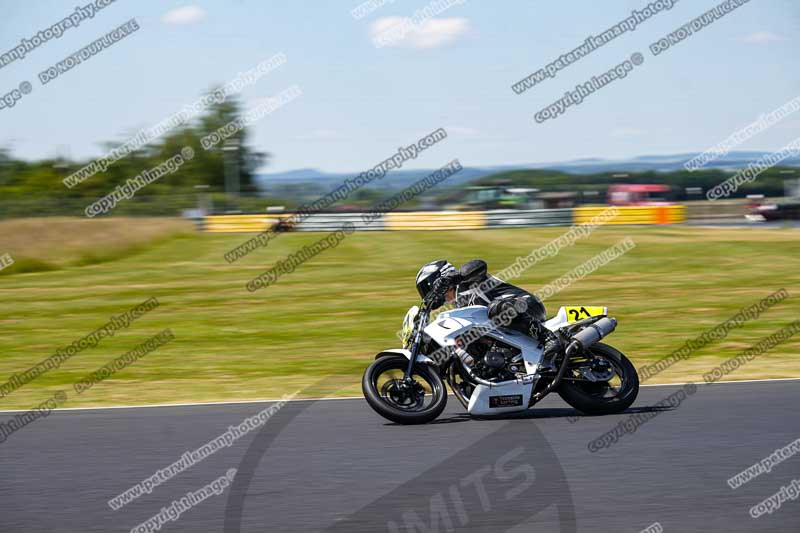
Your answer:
[361,288,639,424]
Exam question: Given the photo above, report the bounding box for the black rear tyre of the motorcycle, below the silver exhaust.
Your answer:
[558,342,639,415]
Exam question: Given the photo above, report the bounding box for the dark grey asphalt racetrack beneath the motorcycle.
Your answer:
[0,381,800,533]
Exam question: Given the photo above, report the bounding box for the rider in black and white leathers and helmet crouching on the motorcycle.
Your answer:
[417,259,561,367]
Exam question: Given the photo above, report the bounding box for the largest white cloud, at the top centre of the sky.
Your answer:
[370,17,469,49]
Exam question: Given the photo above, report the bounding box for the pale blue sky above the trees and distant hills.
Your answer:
[0,0,800,172]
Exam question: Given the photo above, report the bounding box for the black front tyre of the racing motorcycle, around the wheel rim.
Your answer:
[361,355,447,424]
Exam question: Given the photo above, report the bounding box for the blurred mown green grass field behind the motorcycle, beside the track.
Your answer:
[0,224,800,409]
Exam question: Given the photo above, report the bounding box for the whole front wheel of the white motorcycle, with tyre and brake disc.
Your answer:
[361,355,447,424]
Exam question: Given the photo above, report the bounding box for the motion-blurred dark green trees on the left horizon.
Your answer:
[0,90,269,217]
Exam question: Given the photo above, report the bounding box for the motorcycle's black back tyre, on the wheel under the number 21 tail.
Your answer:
[558,342,639,415]
